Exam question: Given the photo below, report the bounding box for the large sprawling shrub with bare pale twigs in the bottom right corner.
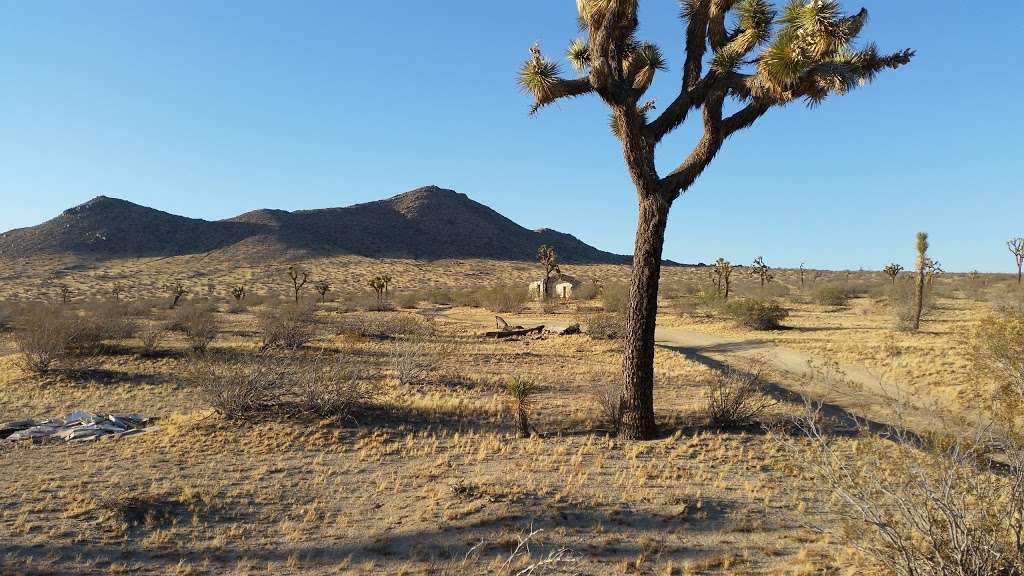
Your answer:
[788,411,1024,576]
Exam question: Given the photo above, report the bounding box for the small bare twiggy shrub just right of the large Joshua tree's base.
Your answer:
[702,368,778,428]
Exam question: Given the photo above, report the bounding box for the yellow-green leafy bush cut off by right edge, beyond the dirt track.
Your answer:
[969,307,1024,423]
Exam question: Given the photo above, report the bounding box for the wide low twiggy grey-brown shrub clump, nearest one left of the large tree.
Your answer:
[194,354,368,420]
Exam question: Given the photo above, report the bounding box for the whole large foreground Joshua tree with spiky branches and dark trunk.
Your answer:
[519,0,913,439]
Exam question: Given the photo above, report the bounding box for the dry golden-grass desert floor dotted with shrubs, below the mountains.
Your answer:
[0,256,1024,574]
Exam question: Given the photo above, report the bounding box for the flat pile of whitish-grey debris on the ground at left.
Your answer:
[0,410,150,442]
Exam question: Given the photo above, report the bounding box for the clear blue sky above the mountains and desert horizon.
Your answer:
[0,0,1024,271]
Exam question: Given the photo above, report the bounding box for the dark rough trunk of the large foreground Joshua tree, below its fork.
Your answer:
[621,195,671,439]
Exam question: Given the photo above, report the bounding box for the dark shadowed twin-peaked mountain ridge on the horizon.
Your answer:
[0,187,632,263]
